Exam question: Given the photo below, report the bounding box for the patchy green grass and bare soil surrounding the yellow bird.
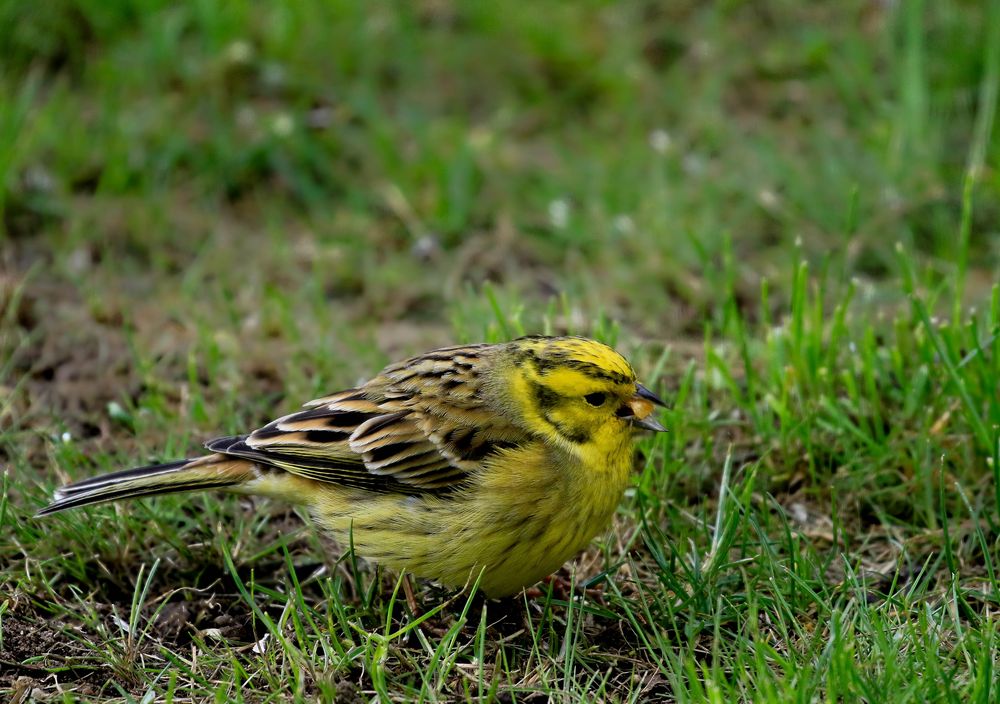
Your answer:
[0,0,1000,703]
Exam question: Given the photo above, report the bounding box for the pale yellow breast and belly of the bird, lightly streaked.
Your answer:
[310,439,631,596]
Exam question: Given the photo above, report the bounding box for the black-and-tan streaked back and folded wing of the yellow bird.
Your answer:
[207,346,523,493]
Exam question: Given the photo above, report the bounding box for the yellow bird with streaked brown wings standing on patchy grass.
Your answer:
[38,336,666,597]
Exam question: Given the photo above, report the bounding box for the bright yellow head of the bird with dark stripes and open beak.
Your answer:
[499,337,665,454]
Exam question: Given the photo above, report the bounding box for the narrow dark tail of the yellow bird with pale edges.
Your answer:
[37,454,258,516]
